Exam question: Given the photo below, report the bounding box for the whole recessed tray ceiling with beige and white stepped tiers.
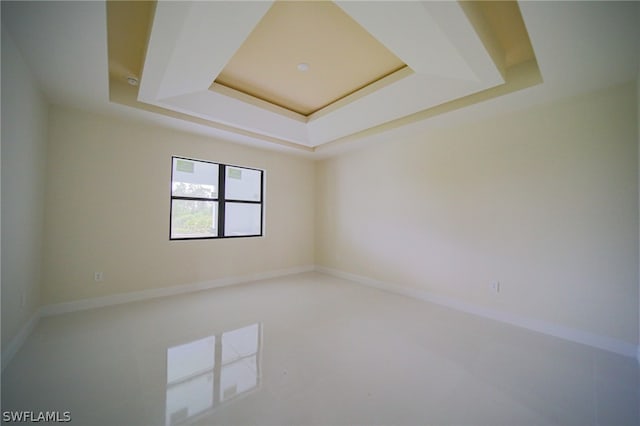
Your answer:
[107,1,541,151]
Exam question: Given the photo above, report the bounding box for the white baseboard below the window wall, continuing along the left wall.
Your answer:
[2,265,315,370]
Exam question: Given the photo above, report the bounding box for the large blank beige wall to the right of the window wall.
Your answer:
[316,83,638,344]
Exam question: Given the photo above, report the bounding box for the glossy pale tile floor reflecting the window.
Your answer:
[2,273,640,426]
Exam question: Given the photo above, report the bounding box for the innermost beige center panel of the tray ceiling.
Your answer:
[215,1,406,116]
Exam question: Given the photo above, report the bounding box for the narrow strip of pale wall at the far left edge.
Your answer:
[1,28,47,350]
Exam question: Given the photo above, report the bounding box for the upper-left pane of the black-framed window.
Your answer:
[171,158,218,198]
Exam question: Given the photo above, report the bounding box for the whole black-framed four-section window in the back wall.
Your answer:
[169,157,264,240]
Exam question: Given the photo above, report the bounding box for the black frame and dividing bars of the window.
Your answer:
[169,155,264,241]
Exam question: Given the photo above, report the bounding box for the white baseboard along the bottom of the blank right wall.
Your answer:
[316,266,640,362]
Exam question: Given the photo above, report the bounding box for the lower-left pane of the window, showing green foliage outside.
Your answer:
[171,200,218,238]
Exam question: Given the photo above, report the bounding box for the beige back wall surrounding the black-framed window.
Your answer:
[43,106,315,304]
